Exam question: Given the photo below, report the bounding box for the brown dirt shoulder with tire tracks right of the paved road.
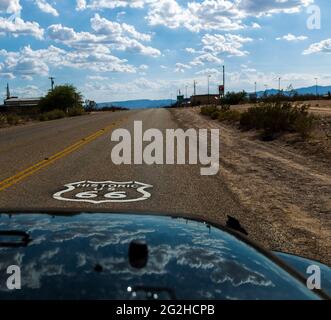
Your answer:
[171,108,331,265]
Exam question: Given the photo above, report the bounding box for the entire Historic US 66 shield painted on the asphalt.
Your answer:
[53,180,153,204]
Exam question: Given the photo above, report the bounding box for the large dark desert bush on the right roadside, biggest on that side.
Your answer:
[240,102,314,138]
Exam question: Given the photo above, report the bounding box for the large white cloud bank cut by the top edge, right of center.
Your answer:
[146,0,313,32]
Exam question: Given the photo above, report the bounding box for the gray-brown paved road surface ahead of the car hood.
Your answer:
[0,109,241,222]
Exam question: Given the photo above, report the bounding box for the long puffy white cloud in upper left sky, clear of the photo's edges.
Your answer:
[48,14,161,57]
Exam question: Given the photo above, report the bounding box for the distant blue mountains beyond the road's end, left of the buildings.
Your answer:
[97,99,176,109]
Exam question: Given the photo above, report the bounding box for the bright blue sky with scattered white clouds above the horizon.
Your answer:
[0,0,331,102]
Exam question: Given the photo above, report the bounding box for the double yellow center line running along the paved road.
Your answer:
[0,120,124,191]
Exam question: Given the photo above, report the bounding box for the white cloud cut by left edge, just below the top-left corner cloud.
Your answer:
[0,17,44,39]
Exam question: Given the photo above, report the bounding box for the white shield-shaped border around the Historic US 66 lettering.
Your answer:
[53,180,153,204]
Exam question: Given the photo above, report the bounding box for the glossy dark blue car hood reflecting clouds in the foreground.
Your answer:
[0,213,326,299]
